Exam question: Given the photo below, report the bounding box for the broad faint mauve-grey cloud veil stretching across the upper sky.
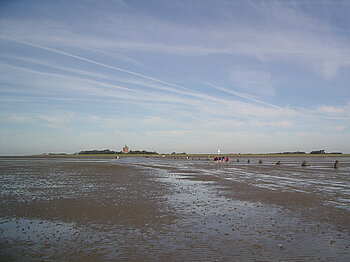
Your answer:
[1,1,350,79]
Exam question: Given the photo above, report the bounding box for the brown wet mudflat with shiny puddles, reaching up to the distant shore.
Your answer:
[0,158,350,261]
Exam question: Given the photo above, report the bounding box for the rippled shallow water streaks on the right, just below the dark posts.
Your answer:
[135,157,350,209]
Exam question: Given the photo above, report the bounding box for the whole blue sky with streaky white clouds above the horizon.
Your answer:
[0,0,350,155]
